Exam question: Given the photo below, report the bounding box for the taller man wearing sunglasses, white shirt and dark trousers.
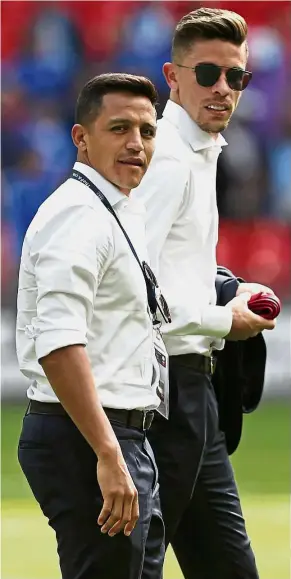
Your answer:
[135,8,274,579]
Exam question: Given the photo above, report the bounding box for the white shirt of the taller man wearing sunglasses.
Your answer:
[134,101,232,356]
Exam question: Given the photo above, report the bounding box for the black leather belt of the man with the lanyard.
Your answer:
[26,400,154,430]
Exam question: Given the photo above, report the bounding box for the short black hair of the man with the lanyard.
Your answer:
[75,72,158,125]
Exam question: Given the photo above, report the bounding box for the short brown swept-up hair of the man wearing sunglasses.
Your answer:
[172,8,248,61]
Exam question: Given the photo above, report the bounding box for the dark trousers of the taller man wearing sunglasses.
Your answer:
[149,354,258,579]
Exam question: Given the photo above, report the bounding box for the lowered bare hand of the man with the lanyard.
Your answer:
[97,447,139,537]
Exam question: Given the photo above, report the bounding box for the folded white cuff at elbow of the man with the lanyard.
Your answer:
[35,330,87,360]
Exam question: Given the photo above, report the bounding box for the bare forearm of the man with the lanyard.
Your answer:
[40,345,119,457]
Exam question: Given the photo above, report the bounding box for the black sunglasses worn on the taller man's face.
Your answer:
[176,62,252,91]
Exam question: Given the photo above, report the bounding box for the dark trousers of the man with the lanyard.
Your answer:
[18,414,164,579]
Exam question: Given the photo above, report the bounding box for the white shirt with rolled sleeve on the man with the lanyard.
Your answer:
[16,163,160,409]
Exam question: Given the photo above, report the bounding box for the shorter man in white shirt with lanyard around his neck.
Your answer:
[17,74,164,579]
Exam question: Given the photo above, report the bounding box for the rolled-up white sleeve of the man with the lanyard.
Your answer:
[28,206,110,360]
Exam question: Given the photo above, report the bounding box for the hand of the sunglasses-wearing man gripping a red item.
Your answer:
[225,292,276,341]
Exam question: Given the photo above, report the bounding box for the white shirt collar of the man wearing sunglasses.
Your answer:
[163,100,227,151]
